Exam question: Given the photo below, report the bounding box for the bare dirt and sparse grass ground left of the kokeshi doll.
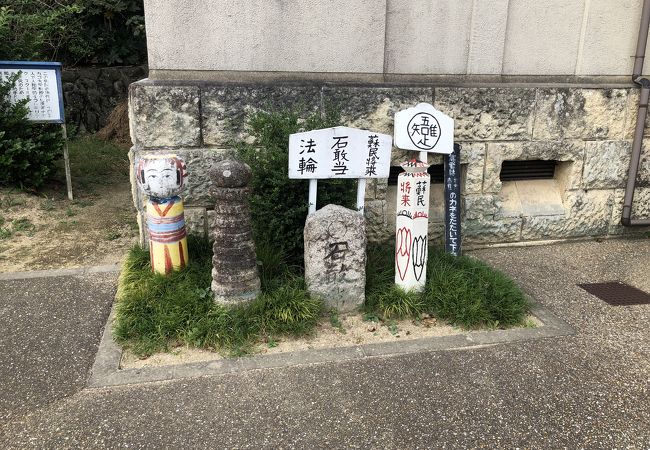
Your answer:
[0,138,138,272]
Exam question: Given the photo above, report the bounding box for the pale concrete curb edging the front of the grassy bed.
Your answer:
[87,304,575,388]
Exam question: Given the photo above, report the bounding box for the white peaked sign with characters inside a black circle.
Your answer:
[395,103,454,154]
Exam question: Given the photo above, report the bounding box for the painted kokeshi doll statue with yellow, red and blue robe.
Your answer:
[137,155,188,274]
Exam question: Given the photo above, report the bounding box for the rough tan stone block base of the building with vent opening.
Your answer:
[129,80,650,244]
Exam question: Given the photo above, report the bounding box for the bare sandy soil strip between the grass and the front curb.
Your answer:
[120,314,544,369]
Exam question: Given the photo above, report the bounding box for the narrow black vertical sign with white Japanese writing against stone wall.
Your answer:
[445,144,461,256]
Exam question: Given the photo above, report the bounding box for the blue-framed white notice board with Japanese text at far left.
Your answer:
[0,61,64,123]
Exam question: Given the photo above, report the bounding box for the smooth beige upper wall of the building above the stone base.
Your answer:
[145,0,641,79]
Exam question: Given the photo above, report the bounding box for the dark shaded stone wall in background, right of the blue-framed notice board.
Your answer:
[61,66,147,133]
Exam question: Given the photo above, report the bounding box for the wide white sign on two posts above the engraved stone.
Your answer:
[289,127,393,179]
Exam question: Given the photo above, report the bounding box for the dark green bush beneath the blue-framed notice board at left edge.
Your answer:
[0,75,63,188]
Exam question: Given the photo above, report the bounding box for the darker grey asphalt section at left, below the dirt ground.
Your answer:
[0,269,117,422]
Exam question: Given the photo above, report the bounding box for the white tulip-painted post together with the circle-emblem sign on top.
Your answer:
[395,103,460,290]
